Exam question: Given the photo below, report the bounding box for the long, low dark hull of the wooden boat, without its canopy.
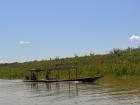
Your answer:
[23,76,101,83]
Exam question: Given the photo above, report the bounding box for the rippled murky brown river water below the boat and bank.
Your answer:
[0,76,140,105]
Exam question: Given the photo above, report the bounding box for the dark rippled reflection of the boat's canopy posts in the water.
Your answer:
[25,82,79,98]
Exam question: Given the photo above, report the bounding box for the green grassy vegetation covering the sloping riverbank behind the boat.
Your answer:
[0,48,140,79]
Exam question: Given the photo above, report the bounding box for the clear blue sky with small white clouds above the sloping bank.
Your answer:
[0,0,140,63]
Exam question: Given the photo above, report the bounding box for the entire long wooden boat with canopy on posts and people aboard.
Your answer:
[23,65,101,83]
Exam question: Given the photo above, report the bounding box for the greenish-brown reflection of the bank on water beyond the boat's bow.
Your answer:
[97,76,140,105]
